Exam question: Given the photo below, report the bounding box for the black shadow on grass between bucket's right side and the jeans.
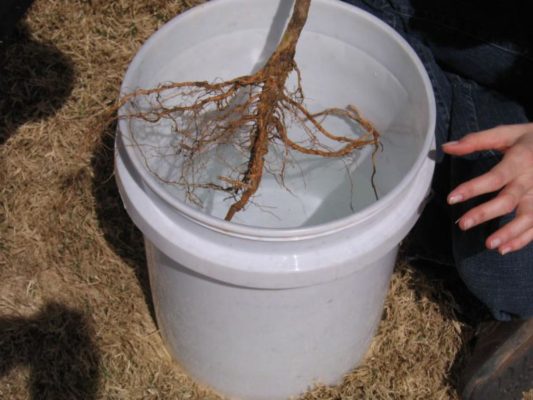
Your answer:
[401,158,490,390]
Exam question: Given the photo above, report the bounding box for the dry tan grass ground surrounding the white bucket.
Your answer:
[0,0,531,400]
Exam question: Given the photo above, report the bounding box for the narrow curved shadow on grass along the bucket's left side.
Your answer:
[91,124,156,321]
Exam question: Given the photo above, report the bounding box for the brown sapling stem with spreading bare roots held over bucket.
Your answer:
[118,0,379,221]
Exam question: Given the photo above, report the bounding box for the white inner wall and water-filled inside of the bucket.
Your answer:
[121,1,429,228]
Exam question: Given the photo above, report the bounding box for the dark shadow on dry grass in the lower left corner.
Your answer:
[0,303,100,400]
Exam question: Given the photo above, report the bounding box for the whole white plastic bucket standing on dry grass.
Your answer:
[116,0,435,400]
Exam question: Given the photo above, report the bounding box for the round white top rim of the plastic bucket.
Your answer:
[118,0,436,241]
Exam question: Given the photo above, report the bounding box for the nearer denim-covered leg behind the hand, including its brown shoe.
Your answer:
[443,76,533,400]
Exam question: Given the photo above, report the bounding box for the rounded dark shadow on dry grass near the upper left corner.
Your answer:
[0,19,75,145]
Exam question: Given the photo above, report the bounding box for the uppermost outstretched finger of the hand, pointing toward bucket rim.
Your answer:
[442,124,533,156]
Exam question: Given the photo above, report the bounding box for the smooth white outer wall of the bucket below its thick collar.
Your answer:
[146,241,397,400]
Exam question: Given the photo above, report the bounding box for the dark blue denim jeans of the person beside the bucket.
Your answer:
[344,0,533,320]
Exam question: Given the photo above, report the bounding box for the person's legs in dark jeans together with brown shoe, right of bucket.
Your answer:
[340,0,533,400]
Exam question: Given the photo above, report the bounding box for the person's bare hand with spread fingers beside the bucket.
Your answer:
[443,123,533,255]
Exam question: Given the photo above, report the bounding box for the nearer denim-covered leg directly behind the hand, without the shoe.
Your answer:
[444,77,533,320]
